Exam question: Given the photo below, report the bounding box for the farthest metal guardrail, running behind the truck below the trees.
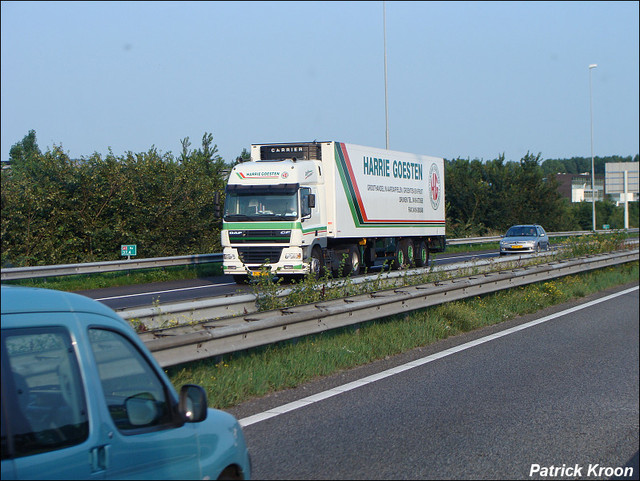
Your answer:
[0,228,638,281]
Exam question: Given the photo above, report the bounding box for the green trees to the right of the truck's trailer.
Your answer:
[445,153,638,238]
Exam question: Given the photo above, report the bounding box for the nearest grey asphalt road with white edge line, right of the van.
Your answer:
[230,284,639,479]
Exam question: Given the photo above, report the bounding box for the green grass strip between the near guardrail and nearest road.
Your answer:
[167,262,639,408]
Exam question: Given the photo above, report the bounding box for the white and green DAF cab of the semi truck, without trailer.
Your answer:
[222,146,327,283]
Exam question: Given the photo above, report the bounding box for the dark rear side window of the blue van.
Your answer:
[2,327,89,459]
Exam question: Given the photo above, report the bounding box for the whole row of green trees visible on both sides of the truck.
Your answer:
[2,130,638,267]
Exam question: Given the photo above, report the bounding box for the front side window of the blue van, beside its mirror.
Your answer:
[89,329,173,434]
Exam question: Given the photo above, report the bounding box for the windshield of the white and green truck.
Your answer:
[224,191,298,220]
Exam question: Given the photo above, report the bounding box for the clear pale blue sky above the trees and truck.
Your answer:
[0,1,640,162]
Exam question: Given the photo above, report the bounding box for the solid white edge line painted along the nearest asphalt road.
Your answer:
[239,286,638,427]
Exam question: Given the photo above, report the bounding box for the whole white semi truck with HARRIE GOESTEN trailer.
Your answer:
[222,141,446,283]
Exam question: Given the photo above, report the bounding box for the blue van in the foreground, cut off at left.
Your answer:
[1,286,251,480]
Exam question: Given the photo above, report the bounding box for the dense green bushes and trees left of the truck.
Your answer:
[2,131,238,267]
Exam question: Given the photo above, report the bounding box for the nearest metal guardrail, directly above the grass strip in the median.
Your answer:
[141,249,639,367]
